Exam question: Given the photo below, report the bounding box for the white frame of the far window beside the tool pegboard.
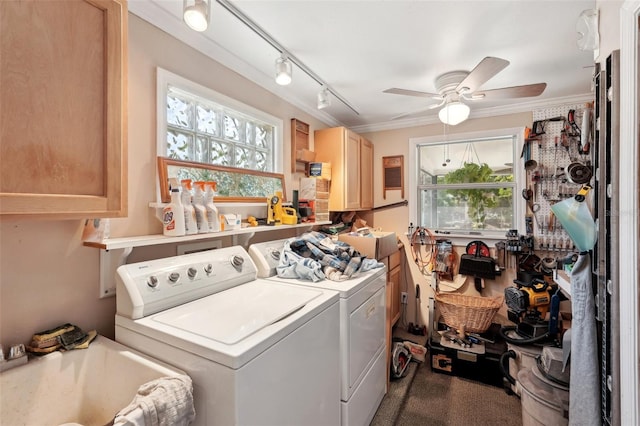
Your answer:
[408,127,526,244]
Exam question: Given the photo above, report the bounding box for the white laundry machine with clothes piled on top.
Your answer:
[249,239,389,426]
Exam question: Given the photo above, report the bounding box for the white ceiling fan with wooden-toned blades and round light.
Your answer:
[384,56,547,125]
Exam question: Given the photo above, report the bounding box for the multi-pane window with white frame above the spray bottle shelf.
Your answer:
[157,68,283,201]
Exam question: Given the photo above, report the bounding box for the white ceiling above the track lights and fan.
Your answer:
[129,0,595,131]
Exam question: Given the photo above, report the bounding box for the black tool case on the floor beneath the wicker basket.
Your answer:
[427,324,507,388]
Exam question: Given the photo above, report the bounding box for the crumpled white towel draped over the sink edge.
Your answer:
[113,375,196,426]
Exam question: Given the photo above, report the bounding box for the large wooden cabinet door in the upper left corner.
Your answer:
[0,0,127,218]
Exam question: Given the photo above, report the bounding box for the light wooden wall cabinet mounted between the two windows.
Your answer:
[314,127,373,211]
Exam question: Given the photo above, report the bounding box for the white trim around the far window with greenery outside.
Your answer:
[407,127,525,239]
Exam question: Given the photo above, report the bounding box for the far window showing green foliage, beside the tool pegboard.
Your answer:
[410,129,522,237]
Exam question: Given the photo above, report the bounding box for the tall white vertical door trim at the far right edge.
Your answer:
[618,0,640,425]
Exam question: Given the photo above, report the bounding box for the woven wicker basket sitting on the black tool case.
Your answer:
[435,292,504,333]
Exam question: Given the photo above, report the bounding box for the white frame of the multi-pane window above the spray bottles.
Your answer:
[156,67,284,203]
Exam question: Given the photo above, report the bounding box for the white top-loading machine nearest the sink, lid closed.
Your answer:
[115,246,340,426]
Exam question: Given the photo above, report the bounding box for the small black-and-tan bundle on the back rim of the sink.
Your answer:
[27,324,97,355]
